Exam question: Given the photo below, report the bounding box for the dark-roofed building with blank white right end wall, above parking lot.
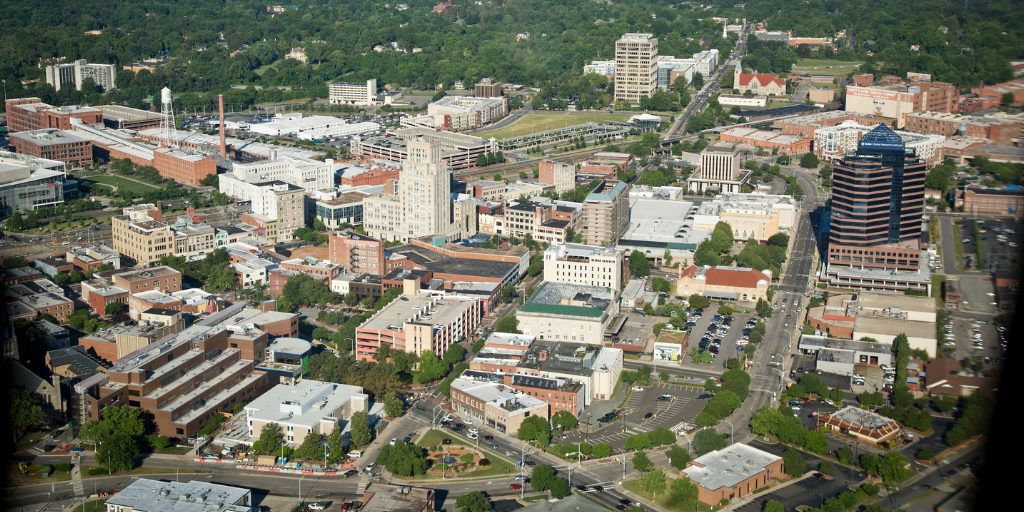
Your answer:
[511,340,623,403]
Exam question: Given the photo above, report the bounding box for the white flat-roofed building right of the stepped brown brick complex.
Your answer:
[245,380,370,444]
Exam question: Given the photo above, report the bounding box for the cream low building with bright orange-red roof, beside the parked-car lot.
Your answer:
[676,265,771,303]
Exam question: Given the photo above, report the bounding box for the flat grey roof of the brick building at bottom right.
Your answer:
[683,442,782,490]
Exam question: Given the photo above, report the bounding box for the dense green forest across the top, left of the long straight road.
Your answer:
[0,0,733,109]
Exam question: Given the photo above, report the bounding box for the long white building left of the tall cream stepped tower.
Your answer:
[228,152,334,192]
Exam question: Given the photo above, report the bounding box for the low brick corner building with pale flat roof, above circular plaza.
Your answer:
[451,377,551,433]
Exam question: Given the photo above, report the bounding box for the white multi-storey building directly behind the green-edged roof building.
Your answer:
[544,244,626,291]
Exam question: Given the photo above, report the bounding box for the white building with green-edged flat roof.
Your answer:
[516,282,620,344]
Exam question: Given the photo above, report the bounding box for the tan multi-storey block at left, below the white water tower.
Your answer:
[111,204,174,266]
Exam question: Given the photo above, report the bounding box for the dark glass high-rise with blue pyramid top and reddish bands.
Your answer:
[827,124,926,270]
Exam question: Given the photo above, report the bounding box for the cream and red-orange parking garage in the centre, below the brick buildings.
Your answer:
[355,288,485,360]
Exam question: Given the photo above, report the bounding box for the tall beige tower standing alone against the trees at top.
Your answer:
[615,34,657,104]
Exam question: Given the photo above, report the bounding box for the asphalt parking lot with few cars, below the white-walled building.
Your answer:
[585,382,711,449]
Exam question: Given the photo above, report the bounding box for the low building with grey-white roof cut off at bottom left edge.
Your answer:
[106,478,253,512]
